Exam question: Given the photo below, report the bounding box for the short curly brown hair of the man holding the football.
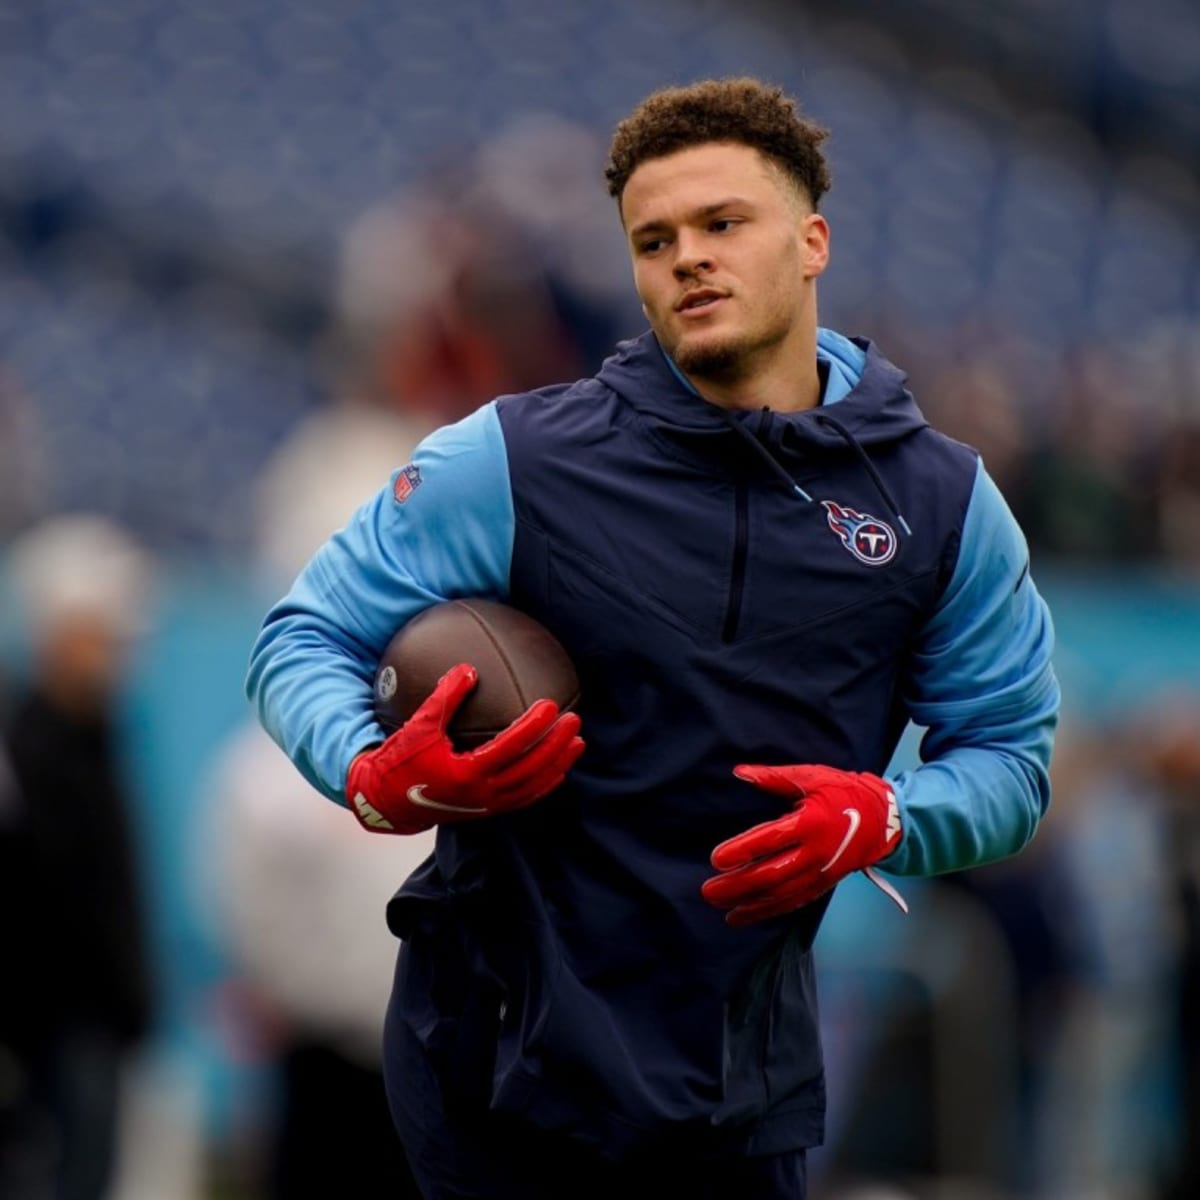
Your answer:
[605,77,830,209]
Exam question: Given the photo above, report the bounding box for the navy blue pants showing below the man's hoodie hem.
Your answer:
[384,952,806,1200]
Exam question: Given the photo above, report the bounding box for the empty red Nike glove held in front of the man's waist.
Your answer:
[701,766,907,925]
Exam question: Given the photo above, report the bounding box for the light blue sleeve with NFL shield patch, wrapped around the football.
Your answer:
[246,403,514,804]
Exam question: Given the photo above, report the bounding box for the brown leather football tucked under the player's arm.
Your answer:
[374,599,580,750]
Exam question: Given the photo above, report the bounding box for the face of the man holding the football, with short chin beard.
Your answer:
[622,142,829,380]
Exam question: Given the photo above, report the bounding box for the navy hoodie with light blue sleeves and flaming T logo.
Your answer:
[248,331,1058,1157]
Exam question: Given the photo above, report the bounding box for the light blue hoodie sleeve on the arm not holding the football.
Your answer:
[880,463,1060,875]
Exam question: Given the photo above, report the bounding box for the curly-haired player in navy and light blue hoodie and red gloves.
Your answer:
[248,79,1058,1200]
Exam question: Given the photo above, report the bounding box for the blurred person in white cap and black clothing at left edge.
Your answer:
[0,516,152,1200]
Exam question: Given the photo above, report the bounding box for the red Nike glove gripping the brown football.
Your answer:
[346,662,583,833]
